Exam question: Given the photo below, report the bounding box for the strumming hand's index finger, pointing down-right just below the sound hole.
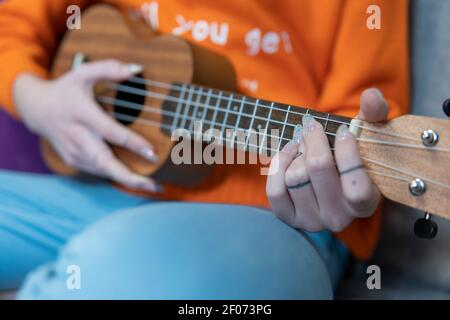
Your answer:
[83,105,158,163]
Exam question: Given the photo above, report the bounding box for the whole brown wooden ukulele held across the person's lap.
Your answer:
[41,5,450,224]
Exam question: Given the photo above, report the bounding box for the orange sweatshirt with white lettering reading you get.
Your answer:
[0,0,409,259]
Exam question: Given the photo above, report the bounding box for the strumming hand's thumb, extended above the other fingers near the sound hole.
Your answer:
[76,59,143,83]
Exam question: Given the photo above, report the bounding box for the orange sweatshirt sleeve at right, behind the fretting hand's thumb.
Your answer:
[319,0,409,118]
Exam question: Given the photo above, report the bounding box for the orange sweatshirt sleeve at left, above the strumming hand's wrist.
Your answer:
[0,0,94,117]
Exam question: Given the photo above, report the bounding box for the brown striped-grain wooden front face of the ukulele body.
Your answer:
[43,6,193,175]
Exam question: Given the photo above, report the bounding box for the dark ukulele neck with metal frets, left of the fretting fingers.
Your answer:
[162,84,352,153]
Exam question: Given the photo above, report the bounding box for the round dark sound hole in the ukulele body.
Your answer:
[114,75,146,126]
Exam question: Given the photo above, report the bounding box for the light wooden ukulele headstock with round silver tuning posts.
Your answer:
[358,115,450,219]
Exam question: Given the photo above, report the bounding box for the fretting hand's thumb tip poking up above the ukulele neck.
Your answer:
[358,88,388,122]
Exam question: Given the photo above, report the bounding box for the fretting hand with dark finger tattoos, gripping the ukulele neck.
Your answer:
[266,89,388,232]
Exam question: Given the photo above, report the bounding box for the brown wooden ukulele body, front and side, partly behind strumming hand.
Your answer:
[41,5,236,185]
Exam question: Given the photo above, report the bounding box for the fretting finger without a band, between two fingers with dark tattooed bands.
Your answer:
[303,116,350,231]
